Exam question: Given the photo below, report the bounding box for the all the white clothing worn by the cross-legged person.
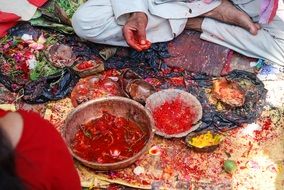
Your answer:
[72,0,284,66]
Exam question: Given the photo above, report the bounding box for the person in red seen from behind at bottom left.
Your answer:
[0,110,81,190]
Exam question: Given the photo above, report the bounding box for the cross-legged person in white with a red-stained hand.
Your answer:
[72,0,284,66]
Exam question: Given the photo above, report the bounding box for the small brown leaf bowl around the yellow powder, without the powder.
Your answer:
[185,130,222,152]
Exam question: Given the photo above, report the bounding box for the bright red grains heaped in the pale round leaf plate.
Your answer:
[153,98,195,135]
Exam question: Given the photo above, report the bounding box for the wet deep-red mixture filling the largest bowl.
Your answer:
[72,112,147,163]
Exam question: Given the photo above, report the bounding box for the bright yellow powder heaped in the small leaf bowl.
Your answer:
[188,131,222,148]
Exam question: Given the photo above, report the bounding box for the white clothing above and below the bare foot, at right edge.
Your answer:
[201,0,284,66]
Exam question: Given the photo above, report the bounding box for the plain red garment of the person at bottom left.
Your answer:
[0,110,81,190]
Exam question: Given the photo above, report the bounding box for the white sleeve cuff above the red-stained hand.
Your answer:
[111,0,148,25]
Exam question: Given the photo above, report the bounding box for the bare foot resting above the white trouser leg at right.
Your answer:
[203,0,260,35]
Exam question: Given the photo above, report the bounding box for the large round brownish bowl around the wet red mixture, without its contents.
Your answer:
[63,96,154,170]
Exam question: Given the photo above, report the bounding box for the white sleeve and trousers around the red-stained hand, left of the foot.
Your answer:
[72,0,221,46]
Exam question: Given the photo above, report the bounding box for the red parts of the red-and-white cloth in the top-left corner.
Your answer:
[0,0,47,38]
